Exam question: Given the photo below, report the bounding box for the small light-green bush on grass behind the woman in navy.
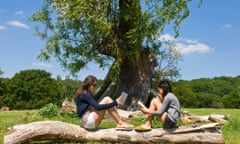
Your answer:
[38,103,60,118]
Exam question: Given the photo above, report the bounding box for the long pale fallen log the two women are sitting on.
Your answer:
[4,121,224,144]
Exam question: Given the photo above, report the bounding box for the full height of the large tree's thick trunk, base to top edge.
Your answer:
[118,0,155,110]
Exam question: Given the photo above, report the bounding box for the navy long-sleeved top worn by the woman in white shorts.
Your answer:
[75,92,117,117]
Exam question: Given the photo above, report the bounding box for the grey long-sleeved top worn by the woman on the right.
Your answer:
[152,93,180,123]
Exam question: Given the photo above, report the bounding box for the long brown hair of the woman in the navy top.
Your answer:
[74,75,97,99]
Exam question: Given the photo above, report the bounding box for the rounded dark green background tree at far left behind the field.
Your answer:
[3,70,63,109]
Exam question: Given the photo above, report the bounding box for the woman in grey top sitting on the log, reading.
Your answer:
[136,80,180,130]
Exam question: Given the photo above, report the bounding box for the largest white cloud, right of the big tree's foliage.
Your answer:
[159,34,213,55]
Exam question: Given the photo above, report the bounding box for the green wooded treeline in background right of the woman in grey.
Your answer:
[174,77,240,108]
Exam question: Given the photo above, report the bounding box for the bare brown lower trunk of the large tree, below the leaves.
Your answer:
[119,50,154,110]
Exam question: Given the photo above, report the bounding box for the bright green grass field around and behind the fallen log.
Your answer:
[0,108,240,144]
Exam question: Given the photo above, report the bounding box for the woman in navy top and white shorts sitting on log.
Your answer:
[74,75,134,129]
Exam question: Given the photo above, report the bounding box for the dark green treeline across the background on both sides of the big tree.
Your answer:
[0,70,240,109]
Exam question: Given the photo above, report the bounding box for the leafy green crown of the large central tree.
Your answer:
[30,0,195,78]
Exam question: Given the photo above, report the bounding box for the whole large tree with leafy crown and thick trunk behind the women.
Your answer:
[31,0,199,109]
